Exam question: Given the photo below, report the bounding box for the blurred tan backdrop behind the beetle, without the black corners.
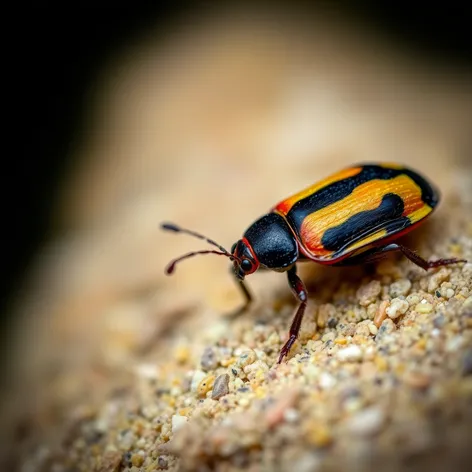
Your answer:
[4,8,472,428]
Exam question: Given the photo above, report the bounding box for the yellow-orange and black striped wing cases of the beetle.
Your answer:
[274,164,439,262]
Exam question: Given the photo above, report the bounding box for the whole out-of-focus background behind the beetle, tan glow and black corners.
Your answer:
[2,2,472,460]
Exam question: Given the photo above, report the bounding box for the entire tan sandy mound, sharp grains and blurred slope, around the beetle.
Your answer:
[2,7,472,472]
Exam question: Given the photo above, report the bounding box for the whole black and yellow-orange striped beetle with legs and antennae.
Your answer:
[161,163,467,363]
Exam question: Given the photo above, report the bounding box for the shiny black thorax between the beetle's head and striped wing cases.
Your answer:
[243,213,298,271]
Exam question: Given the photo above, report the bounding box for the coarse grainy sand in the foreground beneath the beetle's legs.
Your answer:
[7,222,472,472]
